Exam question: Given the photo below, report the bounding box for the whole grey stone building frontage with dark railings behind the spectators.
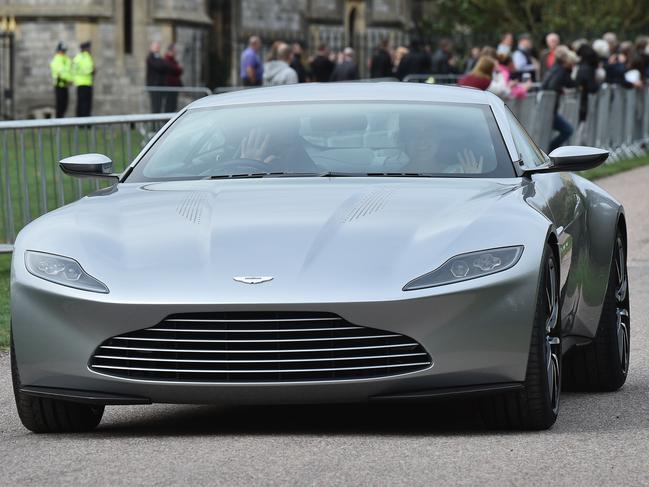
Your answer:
[0,0,421,118]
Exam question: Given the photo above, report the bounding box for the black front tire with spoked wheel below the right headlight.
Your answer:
[481,244,561,430]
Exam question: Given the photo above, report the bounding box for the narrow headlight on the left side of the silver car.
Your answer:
[25,250,108,293]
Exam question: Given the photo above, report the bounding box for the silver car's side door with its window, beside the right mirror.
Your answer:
[508,107,586,334]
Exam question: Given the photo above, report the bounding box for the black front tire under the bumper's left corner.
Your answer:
[10,330,104,433]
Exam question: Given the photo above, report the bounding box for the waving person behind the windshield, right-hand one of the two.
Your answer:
[399,113,484,174]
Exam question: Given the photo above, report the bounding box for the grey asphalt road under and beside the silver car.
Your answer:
[0,167,649,486]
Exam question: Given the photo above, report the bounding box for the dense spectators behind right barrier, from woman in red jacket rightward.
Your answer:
[458,32,649,150]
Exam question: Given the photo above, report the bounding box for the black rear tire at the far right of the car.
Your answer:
[563,231,631,391]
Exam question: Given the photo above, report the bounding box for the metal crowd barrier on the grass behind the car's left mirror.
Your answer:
[0,113,174,246]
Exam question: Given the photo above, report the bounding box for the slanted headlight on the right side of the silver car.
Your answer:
[403,245,523,291]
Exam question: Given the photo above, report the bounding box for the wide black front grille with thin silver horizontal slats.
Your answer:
[90,312,432,382]
